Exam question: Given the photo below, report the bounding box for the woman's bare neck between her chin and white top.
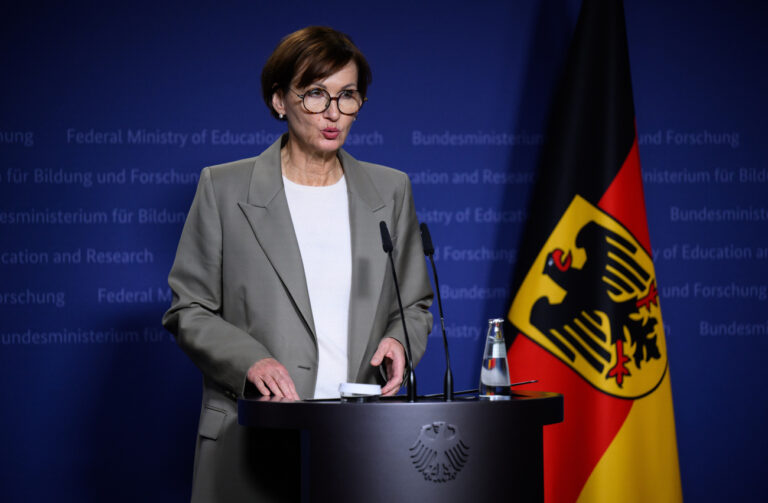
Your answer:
[280,140,344,187]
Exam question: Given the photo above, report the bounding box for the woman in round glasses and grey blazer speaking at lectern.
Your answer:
[163,27,432,501]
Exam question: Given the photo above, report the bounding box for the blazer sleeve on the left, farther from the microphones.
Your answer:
[162,168,272,396]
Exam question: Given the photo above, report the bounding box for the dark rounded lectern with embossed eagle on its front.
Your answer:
[238,391,563,502]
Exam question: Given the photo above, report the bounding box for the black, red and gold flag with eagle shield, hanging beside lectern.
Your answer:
[508,0,682,503]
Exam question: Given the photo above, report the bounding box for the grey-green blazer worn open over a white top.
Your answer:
[163,136,432,501]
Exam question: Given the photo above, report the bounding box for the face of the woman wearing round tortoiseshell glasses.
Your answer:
[272,61,357,155]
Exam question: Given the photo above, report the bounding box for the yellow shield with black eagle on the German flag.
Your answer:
[510,196,667,399]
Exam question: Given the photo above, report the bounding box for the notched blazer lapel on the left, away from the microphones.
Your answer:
[238,140,317,337]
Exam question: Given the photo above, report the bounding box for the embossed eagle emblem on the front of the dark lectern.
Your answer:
[409,421,469,482]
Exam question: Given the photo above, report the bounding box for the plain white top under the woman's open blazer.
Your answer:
[283,176,352,398]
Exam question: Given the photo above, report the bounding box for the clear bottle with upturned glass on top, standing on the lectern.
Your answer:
[478,318,510,400]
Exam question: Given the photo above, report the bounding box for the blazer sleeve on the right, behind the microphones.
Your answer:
[383,173,433,365]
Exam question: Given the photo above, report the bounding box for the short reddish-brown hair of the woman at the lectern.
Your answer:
[261,26,372,118]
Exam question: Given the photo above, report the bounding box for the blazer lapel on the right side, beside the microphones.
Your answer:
[339,150,393,380]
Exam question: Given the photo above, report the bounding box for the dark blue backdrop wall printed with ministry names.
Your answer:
[0,0,768,501]
